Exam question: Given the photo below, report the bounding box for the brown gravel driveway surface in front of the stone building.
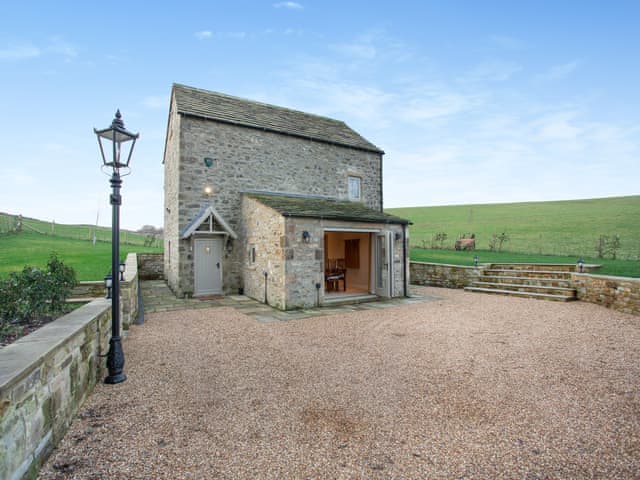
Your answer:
[39,288,640,479]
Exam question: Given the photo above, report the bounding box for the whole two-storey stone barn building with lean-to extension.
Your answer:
[164,85,409,309]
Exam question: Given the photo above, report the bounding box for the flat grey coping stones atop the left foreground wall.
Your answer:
[0,299,111,397]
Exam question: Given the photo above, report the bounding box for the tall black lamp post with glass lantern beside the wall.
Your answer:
[93,110,139,384]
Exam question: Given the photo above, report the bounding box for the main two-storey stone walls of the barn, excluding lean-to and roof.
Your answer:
[164,108,382,295]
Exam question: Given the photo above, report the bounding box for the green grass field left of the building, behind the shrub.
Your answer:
[0,232,162,280]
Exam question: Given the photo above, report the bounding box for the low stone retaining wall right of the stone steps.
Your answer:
[571,273,640,315]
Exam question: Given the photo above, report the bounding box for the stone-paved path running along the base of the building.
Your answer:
[140,280,438,322]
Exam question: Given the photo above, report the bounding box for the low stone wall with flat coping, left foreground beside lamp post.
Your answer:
[0,299,111,480]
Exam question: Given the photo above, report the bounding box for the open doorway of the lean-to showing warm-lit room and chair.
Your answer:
[324,231,374,298]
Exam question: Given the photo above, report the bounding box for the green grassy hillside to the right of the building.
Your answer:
[386,195,640,260]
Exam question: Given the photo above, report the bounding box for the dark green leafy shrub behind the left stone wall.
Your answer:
[0,254,77,330]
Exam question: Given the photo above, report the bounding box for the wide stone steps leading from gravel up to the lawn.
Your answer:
[465,263,577,302]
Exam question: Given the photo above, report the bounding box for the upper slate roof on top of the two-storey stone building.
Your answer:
[173,84,384,153]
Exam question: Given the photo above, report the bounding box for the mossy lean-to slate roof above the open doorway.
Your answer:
[245,193,411,225]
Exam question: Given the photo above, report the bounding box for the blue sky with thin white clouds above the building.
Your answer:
[0,0,640,228]
